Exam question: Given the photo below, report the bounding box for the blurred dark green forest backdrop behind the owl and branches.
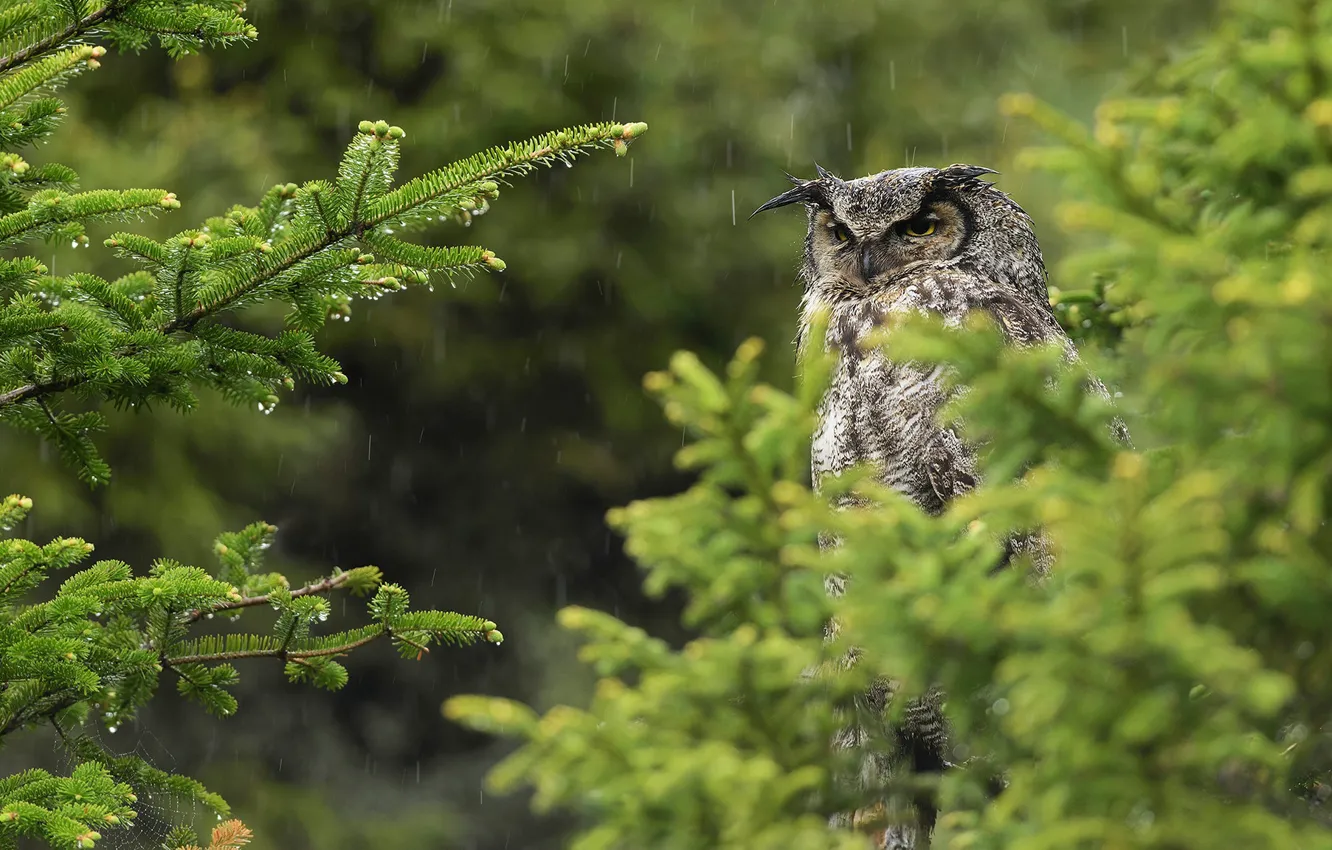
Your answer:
[0,0,1211,850]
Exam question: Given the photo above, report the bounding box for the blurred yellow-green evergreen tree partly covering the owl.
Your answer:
[445,0,1332,850]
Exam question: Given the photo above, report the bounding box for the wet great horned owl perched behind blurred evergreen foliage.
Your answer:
[755,164,1104,846]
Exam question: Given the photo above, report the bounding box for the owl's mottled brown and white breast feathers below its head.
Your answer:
[806,266,1076,513]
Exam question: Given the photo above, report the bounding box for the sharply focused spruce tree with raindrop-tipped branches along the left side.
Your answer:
[0,0,646,850]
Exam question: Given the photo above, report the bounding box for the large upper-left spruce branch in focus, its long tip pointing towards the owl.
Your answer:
[0,115,646,484]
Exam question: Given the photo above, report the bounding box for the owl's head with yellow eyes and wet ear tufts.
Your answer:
[754,164,1046,301]
